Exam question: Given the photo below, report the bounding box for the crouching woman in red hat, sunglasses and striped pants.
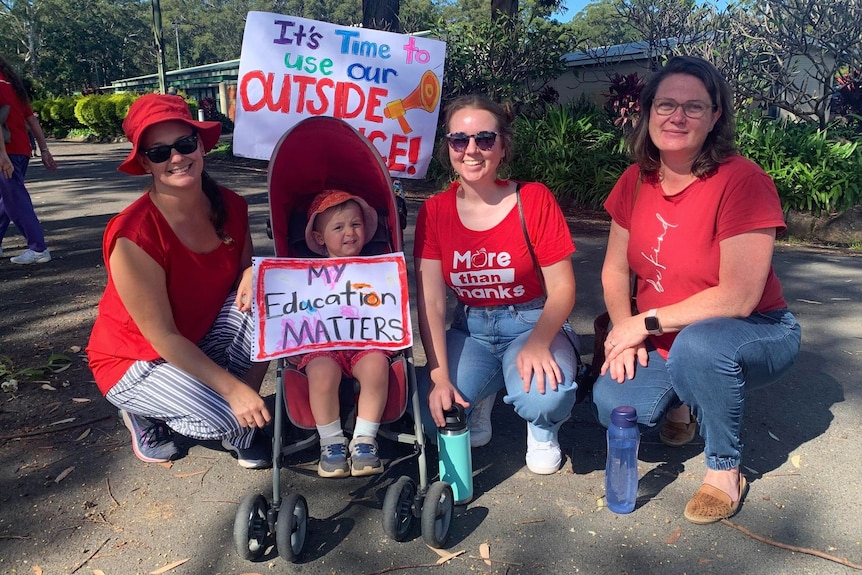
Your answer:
[87,94,272,469]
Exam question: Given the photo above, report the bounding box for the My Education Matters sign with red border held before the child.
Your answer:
[251,253,413,361]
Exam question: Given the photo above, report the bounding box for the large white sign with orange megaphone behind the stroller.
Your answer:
[233,12,446,178]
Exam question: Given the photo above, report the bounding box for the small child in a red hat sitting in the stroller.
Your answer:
[291,190,389,477]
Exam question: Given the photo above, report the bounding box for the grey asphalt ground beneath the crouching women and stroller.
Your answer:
[0,142,862,575]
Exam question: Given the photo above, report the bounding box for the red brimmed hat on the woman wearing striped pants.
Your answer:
[117,94,221,176]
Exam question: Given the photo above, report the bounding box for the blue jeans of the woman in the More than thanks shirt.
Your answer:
[419,298,578,441]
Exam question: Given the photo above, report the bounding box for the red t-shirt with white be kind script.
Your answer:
[605,156,787,357]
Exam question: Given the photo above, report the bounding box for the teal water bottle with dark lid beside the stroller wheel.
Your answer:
[437,403,473,505]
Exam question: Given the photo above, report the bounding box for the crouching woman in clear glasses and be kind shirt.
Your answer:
[593,56,800,524]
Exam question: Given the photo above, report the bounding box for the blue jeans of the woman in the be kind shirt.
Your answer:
[593,309,802,470]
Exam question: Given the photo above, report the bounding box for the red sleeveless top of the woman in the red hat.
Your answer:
[87,188,248,394]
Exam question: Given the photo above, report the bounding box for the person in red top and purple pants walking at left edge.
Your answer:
[0,58,57,264]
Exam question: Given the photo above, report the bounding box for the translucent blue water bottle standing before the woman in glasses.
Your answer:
[605,406,640,513]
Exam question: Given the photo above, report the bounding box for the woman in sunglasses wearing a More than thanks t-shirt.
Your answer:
[414,96,577,474]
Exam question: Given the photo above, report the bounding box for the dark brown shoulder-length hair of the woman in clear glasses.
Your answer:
[626,56,736,179]
